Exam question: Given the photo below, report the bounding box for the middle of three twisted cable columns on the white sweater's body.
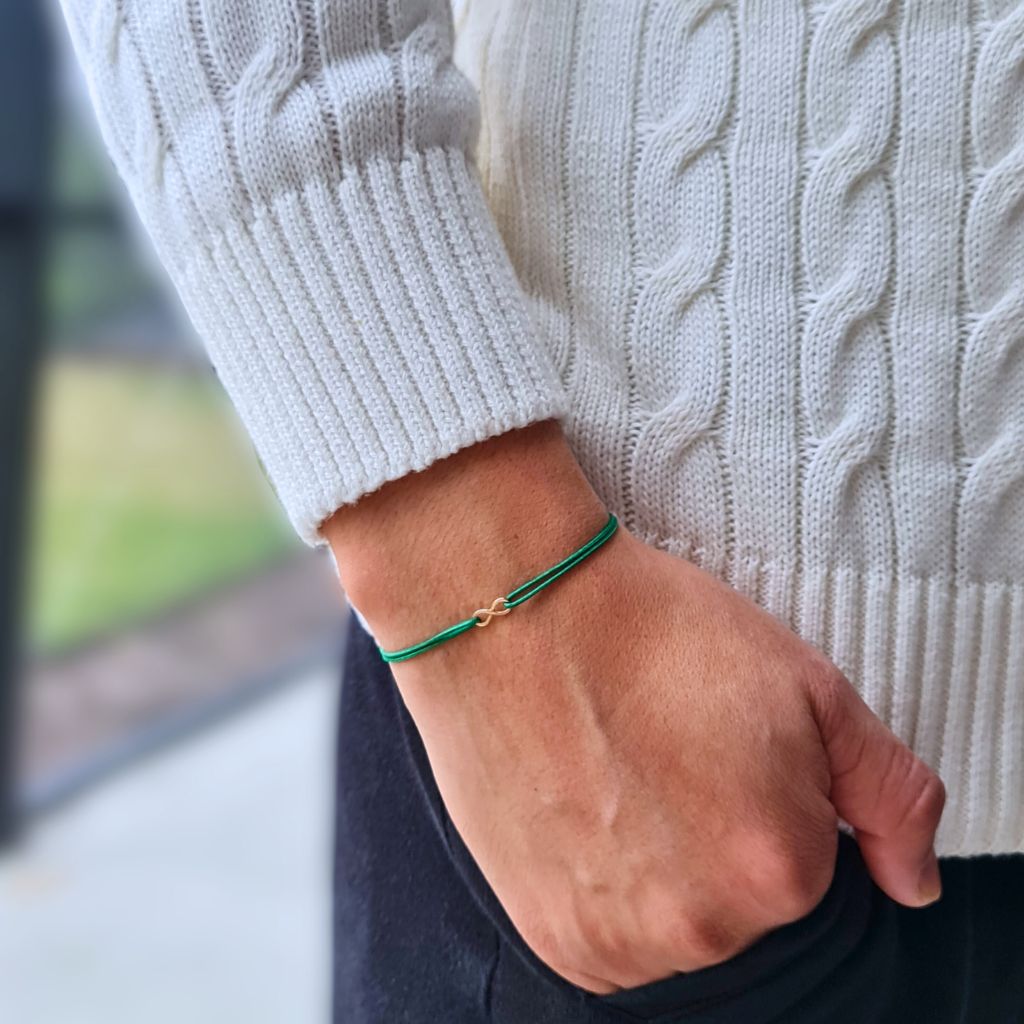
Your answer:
[800,0,896,712]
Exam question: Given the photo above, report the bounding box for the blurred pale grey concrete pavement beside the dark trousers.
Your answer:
[0,671,336,1024]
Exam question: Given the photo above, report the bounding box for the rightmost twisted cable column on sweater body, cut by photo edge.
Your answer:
[956,2,1024,580]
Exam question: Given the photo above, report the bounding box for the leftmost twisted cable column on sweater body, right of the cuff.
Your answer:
[626,0,735,572]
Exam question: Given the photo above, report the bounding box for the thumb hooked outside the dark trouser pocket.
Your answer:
[811,673,946,906]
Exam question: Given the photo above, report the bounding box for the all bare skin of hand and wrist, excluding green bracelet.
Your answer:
[324,422,945,992]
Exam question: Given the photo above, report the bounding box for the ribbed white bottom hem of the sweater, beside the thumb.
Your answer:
[635,530,1024,856]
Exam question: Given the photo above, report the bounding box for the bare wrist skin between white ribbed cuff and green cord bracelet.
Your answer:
[324,421,607,649]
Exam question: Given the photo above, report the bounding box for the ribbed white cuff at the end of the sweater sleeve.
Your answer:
[175,148,566,544]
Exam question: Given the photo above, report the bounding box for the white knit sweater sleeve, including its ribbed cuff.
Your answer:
[60,0,565,544]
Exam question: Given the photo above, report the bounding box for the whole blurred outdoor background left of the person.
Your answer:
[0,0,344,1024]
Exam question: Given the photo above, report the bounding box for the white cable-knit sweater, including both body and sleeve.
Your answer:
[62,0,1024,854]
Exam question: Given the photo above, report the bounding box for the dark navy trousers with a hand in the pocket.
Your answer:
[333,618,1024,1024]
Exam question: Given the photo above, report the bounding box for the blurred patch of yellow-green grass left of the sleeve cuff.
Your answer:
[28,356,298,653]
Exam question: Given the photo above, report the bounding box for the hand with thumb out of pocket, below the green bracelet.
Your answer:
[395,535,943,992]
